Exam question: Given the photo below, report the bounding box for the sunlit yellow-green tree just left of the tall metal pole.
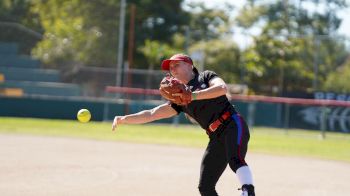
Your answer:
[32,0,118,66]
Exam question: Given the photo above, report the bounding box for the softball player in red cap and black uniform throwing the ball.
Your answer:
[112,54,255,196]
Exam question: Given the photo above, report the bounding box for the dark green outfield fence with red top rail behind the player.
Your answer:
[0,86,350,137]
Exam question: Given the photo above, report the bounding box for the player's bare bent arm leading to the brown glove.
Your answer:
[192,77,227,100]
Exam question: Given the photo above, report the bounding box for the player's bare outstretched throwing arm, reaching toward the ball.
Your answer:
[112,103,177,131]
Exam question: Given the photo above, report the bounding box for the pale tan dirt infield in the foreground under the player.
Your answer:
[0,134,350,196]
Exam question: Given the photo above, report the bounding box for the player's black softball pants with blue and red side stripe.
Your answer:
[198,114,250,196]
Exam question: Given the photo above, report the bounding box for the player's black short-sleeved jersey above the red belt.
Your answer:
[171,70,234,129]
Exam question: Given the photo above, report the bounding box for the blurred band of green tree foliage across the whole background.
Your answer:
[0,0,349,95]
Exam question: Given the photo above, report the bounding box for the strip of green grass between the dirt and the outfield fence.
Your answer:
[0,118,350,162]
